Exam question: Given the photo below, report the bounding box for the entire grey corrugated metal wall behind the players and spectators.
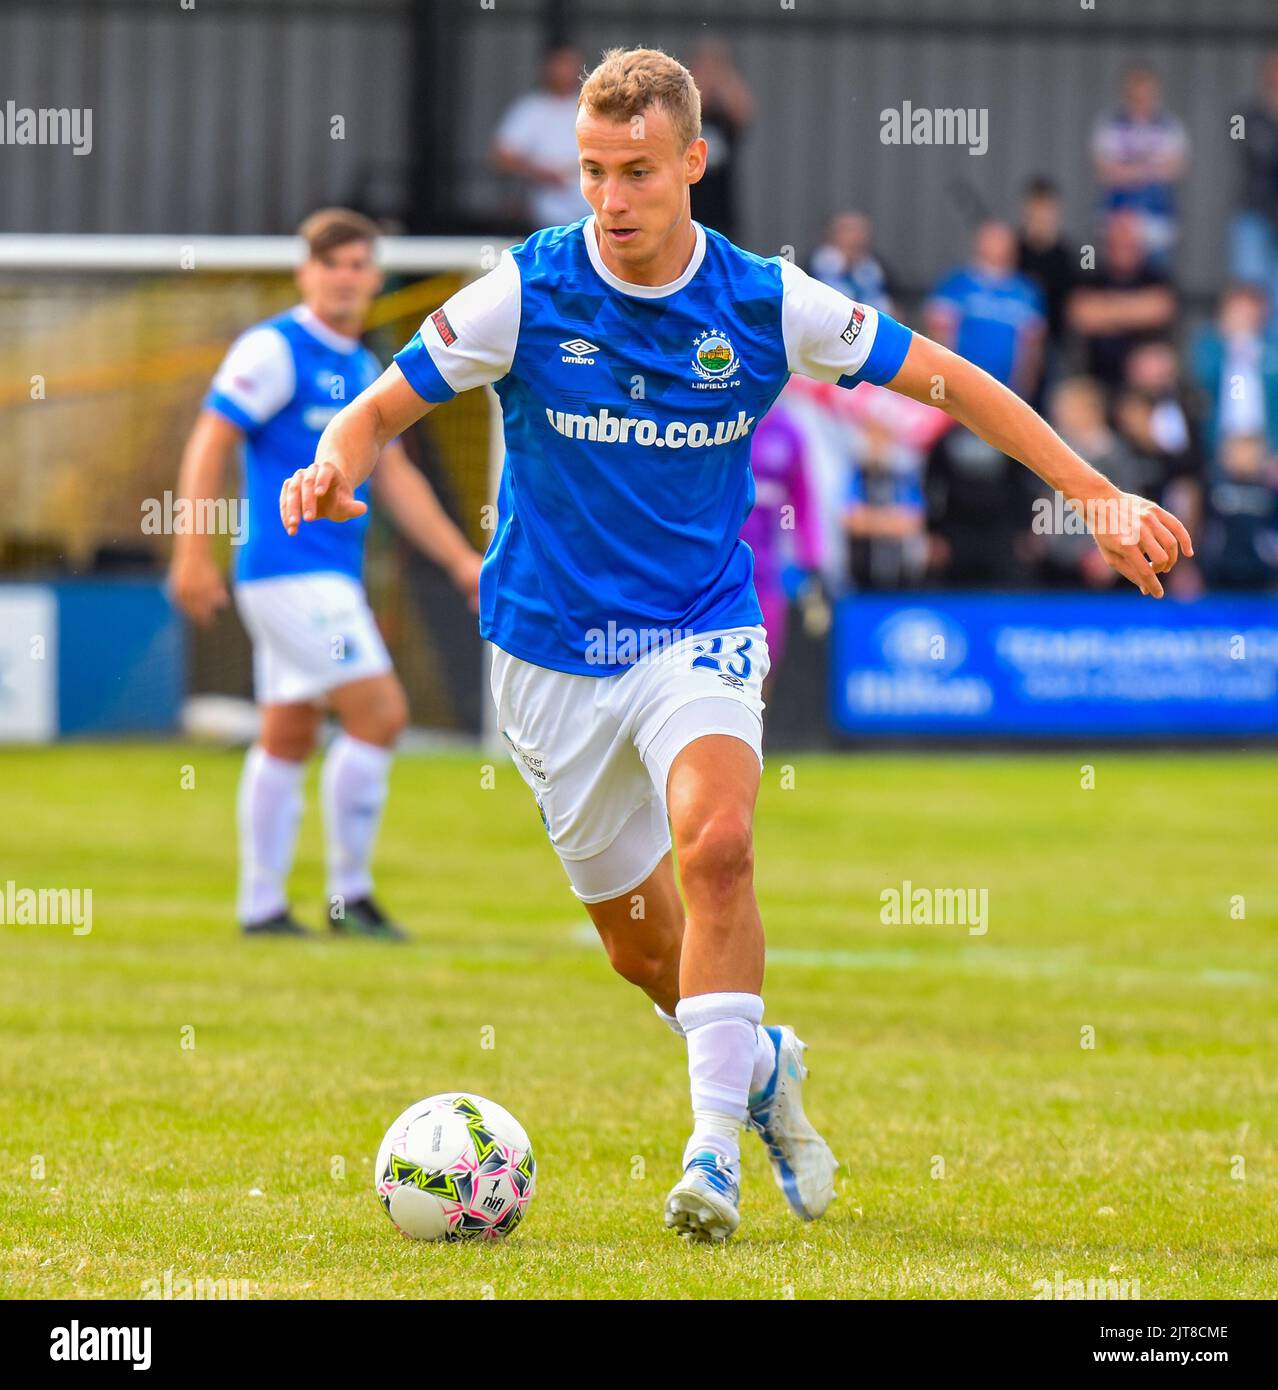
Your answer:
[0,0,1278,288]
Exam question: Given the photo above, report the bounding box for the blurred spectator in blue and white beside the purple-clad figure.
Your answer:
[843,420,928,589]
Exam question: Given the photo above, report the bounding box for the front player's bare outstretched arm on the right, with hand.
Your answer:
[887,334,1193,599]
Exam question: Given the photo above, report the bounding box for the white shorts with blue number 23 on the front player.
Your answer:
[492,627,769,902]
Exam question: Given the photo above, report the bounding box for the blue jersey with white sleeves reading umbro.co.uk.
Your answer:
[395,217,911,676]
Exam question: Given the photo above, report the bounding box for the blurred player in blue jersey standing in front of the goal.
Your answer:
[172,209,480,938]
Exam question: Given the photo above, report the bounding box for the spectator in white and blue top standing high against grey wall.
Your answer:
[1092,67,1189,261]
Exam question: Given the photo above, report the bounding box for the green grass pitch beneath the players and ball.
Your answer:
[0,745,1278,1298]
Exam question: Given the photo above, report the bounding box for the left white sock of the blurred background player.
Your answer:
[236,744,306,923]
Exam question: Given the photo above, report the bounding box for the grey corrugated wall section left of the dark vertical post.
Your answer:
[0,0,409,234]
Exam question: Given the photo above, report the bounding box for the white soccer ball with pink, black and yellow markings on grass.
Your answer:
[374,1091,537,1240]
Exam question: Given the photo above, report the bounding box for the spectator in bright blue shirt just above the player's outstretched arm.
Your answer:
[923,221,1046,396]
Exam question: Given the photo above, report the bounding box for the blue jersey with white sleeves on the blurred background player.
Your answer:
[204,307,381,581]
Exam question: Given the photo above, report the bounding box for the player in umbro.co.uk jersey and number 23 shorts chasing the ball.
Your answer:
[280,49,1189,1240]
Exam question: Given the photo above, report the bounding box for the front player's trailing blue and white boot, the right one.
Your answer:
[745,1024,839,1220]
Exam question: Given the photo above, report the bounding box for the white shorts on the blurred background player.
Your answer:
[235,571,391,705]
